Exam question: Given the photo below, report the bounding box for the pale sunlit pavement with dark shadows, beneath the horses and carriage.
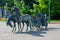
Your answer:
[0,22,60,40]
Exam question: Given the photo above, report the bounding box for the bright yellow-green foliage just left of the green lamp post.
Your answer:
[33,0,48,14]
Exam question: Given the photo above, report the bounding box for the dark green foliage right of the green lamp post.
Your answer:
[51,0,60,18]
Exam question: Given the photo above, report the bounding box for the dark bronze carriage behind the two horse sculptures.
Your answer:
[32,13,48,30]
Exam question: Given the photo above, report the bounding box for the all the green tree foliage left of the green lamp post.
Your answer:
[1,0,49,16]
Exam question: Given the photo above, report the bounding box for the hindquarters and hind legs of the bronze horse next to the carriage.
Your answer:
[18,14,31,31]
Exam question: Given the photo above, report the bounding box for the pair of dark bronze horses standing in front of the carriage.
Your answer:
[7,8,31,32]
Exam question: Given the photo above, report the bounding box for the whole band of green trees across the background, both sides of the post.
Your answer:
[0,0,60,17]
